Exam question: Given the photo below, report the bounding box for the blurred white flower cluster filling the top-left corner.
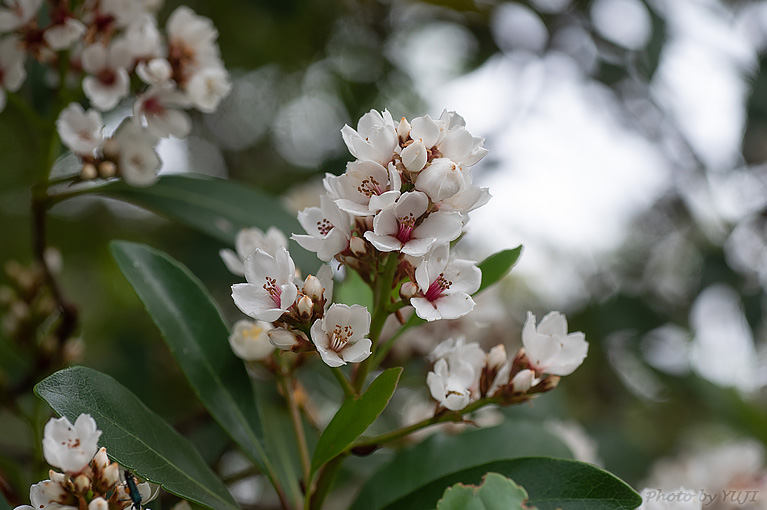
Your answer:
[0,0,230,186]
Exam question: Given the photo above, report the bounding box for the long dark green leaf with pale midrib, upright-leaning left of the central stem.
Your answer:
[110,241,272,484]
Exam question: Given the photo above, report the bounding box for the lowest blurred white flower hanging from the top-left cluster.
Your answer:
[112,117,162,186]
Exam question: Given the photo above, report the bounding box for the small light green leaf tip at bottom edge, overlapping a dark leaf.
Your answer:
[437,473,534,510]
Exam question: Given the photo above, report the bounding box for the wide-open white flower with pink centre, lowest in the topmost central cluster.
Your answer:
[365,191,463,257]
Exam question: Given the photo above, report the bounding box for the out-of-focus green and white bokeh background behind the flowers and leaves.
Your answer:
[0,0,767,508]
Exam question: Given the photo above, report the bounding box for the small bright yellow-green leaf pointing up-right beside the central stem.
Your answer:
[312,367,402,473]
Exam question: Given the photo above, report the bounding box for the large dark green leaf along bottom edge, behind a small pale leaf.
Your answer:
[384,457,642,510]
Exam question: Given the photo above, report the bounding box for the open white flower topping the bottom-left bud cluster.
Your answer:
[43,414,101,473]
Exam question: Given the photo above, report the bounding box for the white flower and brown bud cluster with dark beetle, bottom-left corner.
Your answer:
[15,414,153,510]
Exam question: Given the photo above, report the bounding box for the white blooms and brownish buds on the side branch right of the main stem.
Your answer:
[426,312,588,412]
